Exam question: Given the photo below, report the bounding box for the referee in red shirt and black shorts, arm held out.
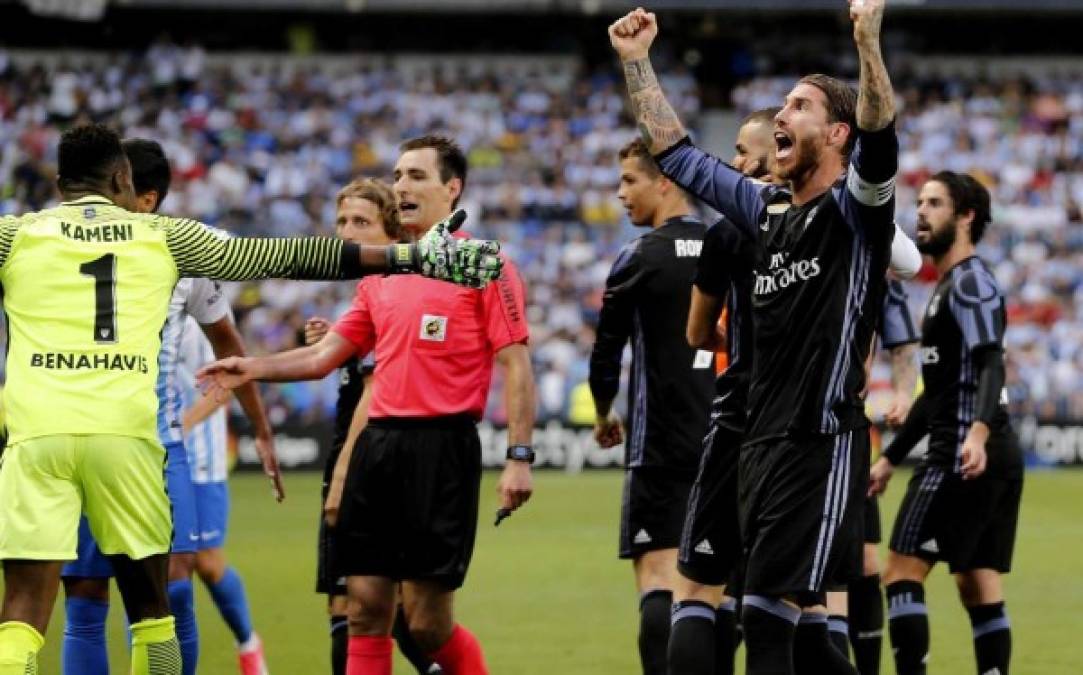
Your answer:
[201,137,535,675]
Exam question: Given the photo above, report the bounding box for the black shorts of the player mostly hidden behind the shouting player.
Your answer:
[677,425,743,586]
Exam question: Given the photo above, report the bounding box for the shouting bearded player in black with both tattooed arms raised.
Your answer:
[610,0,898,675]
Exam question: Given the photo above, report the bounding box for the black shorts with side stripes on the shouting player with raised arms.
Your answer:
[739,429,870,597]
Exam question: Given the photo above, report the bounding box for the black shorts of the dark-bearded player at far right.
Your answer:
[891,464,1022,574]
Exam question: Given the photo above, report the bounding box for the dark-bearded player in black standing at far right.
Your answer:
[870,171,1023,675]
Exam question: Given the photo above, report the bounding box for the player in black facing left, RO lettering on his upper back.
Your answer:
[589,139,715,675]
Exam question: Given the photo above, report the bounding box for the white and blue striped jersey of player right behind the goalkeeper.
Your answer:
[155,278,230,443]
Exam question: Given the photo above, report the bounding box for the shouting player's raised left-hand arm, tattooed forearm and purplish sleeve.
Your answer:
[609,9,764,233]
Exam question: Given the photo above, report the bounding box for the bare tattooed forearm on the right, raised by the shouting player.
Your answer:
[850,0,895,131]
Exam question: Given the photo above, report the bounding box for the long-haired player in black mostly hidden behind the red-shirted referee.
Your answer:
[304,179,439,675]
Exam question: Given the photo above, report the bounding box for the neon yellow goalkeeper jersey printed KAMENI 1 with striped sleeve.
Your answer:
[0,196,350,443]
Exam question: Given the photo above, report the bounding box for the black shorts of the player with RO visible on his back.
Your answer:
[621,467,695,559]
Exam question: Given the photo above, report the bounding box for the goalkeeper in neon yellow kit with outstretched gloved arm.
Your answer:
[0,125,500,675]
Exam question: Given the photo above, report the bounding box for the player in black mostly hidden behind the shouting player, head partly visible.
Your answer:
[668,108,780,675]
